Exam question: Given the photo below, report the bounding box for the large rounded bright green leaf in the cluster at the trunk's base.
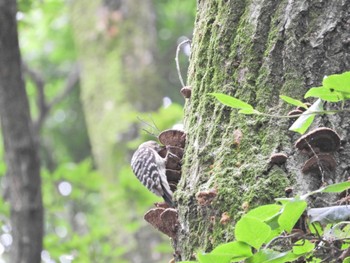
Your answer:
[235,216,271,249]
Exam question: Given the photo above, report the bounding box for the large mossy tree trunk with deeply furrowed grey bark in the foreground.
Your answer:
[176,0,350,260]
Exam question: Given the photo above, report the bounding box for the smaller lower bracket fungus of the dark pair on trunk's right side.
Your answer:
[302,153,337,174]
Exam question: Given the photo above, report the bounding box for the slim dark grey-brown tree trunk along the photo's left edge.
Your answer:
[0,0,43,263]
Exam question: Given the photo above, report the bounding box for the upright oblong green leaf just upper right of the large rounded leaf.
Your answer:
[278,200,307,233]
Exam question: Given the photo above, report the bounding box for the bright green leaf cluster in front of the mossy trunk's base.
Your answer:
[182,182,350,263]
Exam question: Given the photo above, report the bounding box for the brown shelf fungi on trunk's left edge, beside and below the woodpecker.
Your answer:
[144,129,186,238]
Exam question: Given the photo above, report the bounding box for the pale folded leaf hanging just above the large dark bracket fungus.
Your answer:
[289,99,323,134]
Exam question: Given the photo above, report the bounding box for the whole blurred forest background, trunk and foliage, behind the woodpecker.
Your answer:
[0,0,196,263]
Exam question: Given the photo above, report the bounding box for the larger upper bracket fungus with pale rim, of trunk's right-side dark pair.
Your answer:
[295,127,340,155]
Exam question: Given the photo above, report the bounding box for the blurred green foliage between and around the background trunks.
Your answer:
[0,0,196,263]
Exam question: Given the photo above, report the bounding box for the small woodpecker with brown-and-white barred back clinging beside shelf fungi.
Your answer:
[131,141,174,207]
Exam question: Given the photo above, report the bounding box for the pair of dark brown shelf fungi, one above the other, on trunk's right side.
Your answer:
[295,127,340,174]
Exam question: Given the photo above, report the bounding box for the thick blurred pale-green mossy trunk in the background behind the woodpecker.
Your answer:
[71,0,165,263]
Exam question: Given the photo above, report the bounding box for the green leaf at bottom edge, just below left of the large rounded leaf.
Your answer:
[210,241,252,262]
